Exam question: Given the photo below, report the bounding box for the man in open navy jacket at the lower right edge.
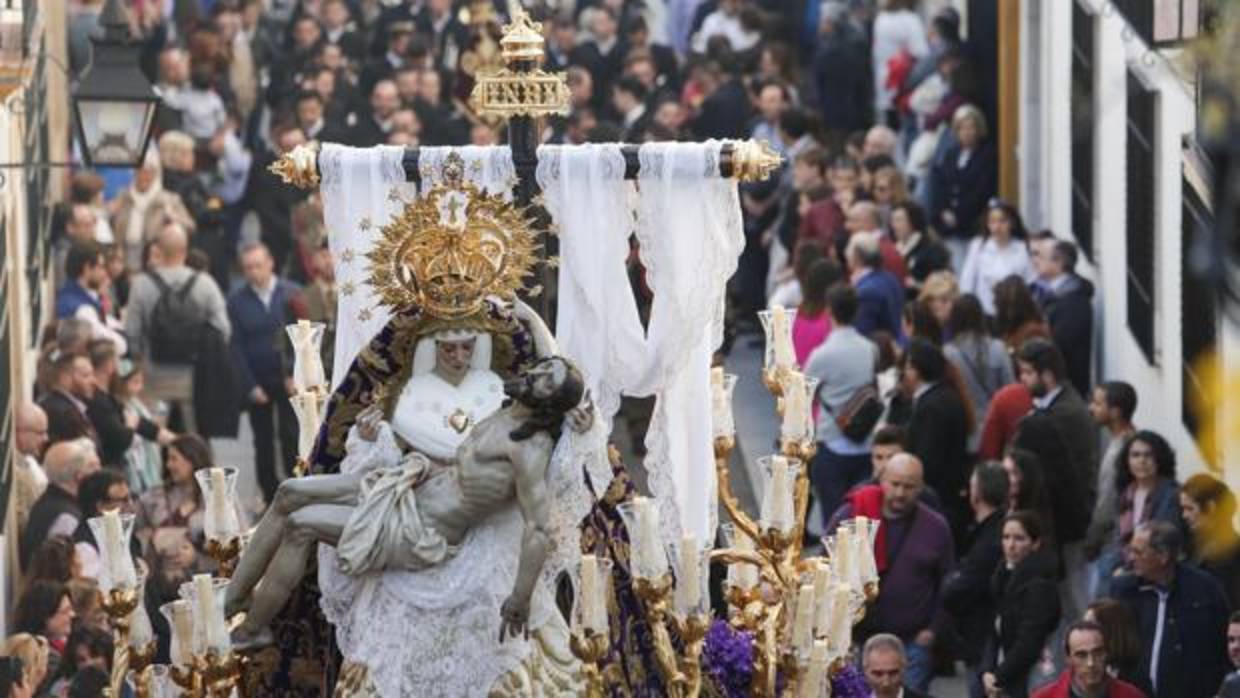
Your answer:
[1111,521,1229,698]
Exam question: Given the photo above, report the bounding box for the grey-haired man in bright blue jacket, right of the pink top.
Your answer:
[844,224,904,341]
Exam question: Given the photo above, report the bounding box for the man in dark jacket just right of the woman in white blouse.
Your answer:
[1029,231,1094,395]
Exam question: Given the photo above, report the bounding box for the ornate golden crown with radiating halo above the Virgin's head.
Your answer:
[367,162,538,320]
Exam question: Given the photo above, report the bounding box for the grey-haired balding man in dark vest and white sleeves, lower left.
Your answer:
[21,439,99,567]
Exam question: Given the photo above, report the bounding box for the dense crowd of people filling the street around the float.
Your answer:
[0,0,1240,698]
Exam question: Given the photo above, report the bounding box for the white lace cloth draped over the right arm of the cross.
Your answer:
[538,141,744,543]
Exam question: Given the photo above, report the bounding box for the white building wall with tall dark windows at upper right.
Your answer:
[1018,0,1240,486]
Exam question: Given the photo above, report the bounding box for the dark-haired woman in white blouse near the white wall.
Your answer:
[960,198,1033,315]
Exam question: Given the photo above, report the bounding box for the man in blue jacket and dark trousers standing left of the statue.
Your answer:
[228,243,304,502]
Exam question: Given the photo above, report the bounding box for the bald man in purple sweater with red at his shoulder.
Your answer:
[827,453,955,692]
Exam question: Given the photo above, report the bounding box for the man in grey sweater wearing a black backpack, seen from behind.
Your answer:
[125,223,232,431]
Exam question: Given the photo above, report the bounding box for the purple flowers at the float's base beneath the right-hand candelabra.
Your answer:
[702,619,869,698]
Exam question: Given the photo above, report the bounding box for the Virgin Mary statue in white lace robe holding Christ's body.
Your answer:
[283,167,610,698]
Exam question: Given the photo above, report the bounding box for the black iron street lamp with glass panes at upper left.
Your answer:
[73,0,160,167]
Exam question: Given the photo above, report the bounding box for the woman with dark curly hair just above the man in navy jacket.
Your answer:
[1100,429,1184,574]
